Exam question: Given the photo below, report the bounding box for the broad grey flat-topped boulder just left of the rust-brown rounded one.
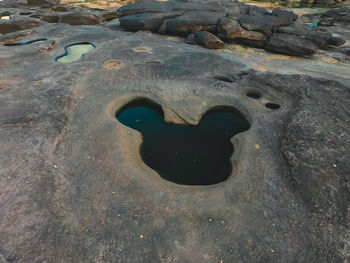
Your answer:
[159,11,226,36]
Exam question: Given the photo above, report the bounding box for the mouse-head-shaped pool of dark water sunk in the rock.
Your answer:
[116,100,250,185]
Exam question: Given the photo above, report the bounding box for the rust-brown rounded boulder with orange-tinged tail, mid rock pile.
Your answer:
[217,17,266,42]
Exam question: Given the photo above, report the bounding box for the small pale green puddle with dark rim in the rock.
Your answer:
[56,42,96,63]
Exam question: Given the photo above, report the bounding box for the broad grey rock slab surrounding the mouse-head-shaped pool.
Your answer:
[0,2,350,263]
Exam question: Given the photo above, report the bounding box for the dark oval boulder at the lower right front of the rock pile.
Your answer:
[264,33,317,56]
